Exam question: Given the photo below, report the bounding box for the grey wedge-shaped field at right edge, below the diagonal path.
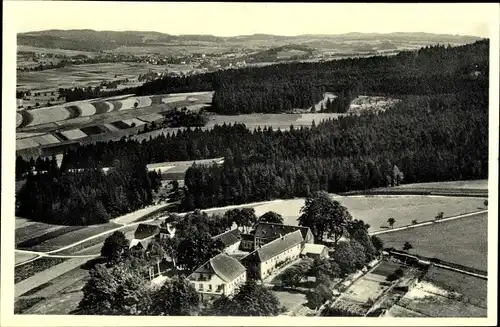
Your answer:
[379,213,488,270]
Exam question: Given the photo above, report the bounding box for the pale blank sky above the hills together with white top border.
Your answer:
[4,0,498,37]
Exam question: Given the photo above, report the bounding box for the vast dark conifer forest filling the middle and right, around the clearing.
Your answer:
[14,41,489,220]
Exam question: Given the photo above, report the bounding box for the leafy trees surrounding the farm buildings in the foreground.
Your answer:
[81,192,382,316]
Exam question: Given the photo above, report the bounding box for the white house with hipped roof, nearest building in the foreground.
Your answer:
[187,253,247,299]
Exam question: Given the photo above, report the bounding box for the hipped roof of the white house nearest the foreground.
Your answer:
[188,253,246,283]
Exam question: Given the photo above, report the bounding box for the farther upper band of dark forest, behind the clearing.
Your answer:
[57,40,489,114]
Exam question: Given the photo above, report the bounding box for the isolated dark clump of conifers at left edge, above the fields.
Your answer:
[16,157,161,225]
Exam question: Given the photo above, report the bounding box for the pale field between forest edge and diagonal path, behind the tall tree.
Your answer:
[255,195,484,232]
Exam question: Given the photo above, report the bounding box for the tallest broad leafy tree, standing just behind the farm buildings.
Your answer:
[298,191,352,245]
